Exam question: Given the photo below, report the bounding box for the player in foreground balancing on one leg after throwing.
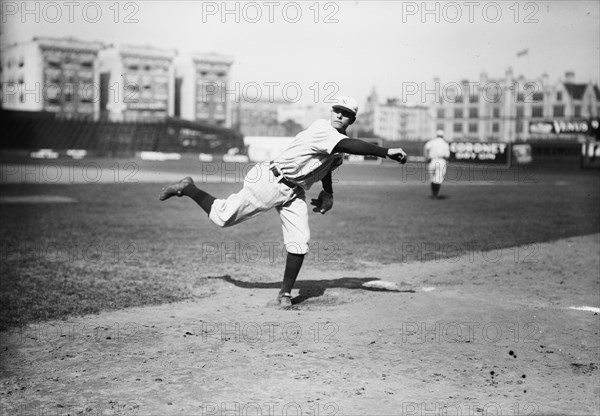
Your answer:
[159,97,406,308]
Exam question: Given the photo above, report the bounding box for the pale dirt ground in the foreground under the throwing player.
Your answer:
[0,234,600,415]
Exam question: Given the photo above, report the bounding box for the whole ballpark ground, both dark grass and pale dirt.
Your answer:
[0,160,600,416]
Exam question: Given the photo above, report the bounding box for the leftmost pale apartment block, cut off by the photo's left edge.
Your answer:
[1,37,104,119]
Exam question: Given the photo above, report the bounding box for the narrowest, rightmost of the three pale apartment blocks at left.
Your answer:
[175,53,233,127]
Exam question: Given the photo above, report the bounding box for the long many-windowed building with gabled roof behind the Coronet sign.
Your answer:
[431,68,600,142]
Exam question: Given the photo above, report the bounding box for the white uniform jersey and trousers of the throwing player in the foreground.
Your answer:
[209,119,348,254]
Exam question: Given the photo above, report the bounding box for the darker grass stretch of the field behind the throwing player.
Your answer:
[0,160,600,329]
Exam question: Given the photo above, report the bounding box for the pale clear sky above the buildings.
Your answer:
[0,0,600,104]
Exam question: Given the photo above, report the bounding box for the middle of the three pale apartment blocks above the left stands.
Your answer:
[99,45,177,121]
